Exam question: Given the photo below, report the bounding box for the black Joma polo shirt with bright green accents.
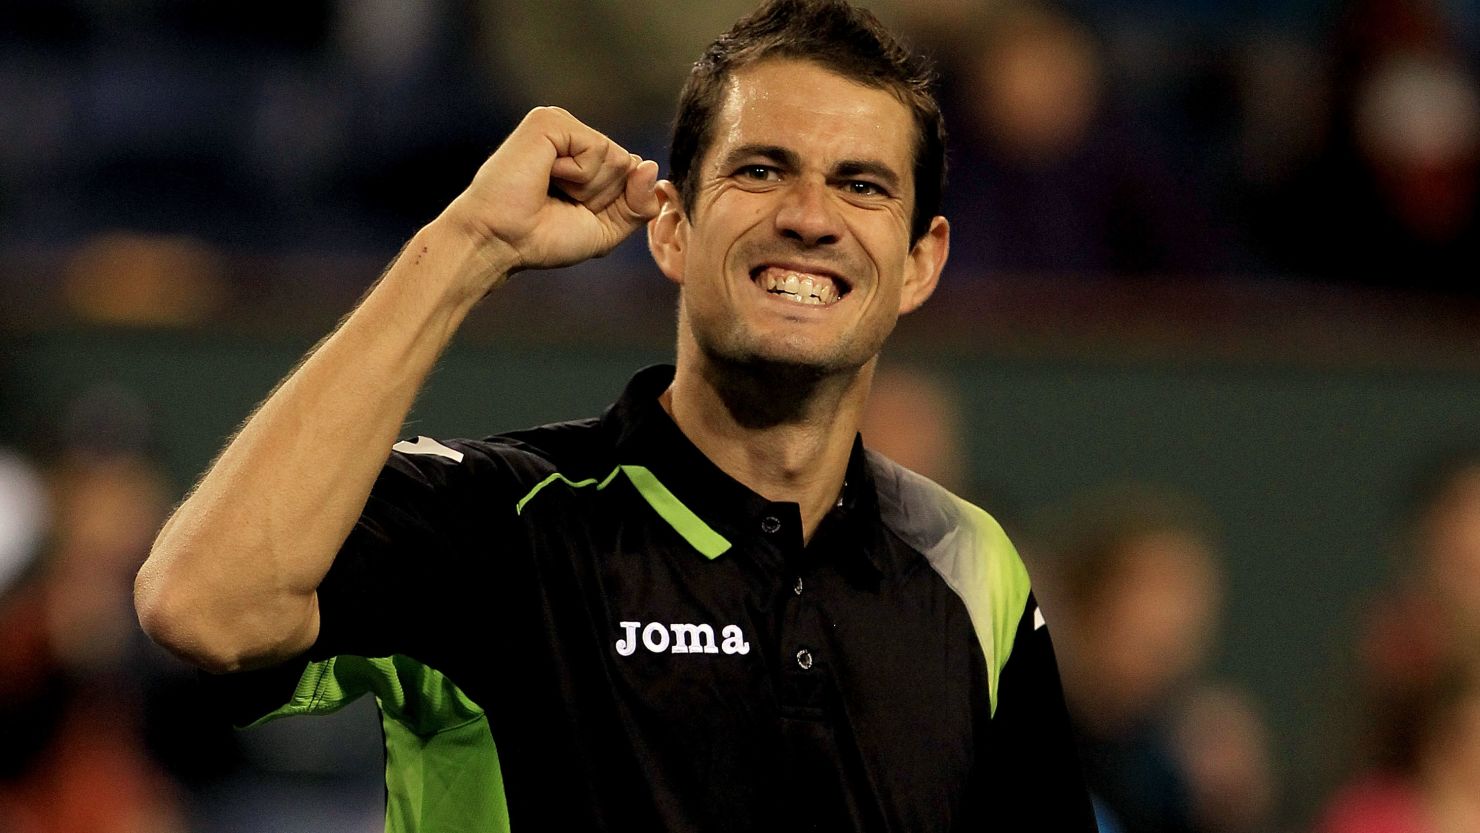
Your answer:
[222,367,1094,832]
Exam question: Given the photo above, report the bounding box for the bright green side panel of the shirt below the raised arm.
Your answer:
[252,655,509,833]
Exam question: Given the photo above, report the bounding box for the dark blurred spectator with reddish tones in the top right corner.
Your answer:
[1251,0,1480,293]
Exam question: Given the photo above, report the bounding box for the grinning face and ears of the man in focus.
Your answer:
[648,59,949,373]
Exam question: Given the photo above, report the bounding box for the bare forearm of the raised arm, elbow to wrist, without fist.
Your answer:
[135,219,502,670]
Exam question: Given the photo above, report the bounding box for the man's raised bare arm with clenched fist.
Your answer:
[135,108,657,672]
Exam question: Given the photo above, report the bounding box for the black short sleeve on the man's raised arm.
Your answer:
[204,438,522,725]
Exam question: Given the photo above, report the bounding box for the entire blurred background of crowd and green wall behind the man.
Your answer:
[0,0,1480,833]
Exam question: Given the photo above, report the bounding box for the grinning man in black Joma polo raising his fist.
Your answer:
[138,0,1094,832]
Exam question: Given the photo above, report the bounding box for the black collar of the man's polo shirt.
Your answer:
[601,365,892,574]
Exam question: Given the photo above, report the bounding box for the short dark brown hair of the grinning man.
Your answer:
[669,0,946,246]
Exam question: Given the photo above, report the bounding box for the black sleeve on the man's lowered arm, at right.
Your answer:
[968,593,1097,833]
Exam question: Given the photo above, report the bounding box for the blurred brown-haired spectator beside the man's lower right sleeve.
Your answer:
[1052,490,1274,833]
